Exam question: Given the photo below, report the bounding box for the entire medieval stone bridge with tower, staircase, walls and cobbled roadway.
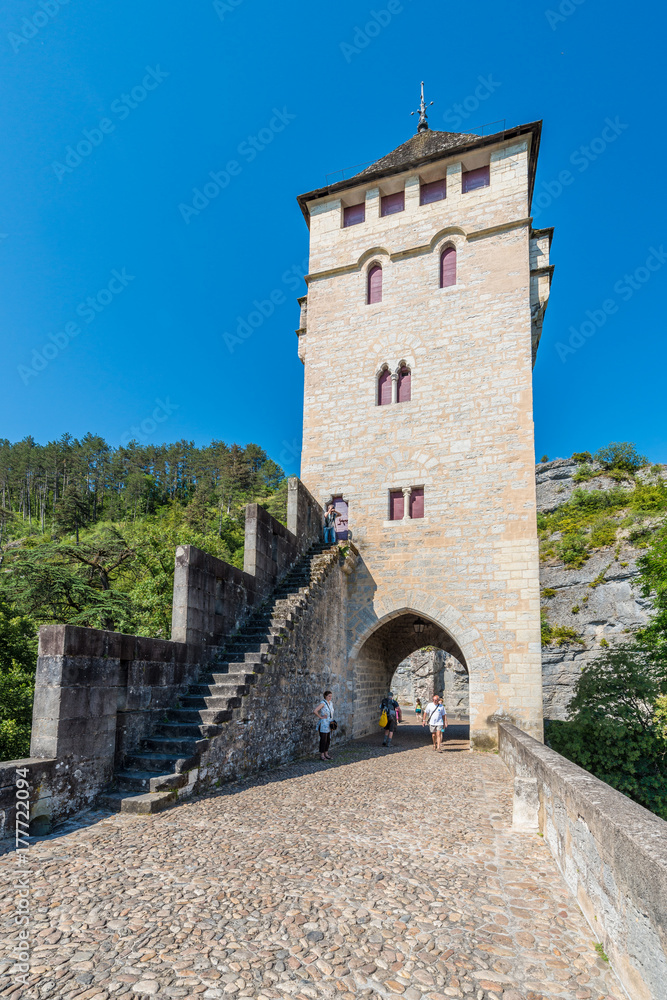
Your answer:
[0,111,667,1000]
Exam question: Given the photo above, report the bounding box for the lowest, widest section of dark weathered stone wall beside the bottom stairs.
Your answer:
[13,625,204,836]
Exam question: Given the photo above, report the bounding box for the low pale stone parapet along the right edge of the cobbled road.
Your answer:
[498,723,667,1000]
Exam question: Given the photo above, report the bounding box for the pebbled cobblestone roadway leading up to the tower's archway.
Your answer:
[0,725,622,1000]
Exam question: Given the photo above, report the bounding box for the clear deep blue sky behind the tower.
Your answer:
[0,0,667,473]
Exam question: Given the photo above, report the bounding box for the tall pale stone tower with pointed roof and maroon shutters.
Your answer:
[297,108,553,746]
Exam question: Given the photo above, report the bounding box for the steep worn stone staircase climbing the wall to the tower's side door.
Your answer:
[98,542,339,813]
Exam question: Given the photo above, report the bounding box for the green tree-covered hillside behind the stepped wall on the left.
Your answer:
[0,434,287,759]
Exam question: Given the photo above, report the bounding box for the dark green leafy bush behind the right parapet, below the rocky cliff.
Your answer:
[547,644,667,819]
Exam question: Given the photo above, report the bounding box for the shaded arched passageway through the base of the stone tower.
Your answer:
[354,609,469,736]
